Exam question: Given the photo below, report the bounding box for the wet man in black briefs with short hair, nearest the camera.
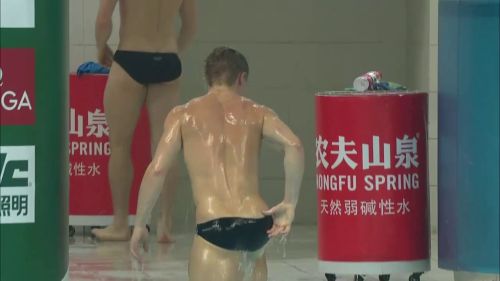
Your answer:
[130,48,304,281]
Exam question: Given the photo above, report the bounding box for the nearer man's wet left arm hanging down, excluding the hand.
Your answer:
[135,107,182,228]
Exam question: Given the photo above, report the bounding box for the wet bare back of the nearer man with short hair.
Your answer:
[177,94,267,222]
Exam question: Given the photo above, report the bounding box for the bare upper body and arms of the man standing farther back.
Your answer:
[96,0,196,67]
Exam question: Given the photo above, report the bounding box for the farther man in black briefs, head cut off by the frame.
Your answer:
[92,0,196,242]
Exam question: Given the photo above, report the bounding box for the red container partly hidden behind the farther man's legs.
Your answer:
[69,75,151,216]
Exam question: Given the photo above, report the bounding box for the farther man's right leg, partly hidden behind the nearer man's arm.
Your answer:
[146,80,179,243]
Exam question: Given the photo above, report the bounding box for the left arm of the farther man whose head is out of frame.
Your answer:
[95,0,118,66]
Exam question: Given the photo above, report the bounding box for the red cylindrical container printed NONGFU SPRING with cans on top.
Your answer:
[316,92,430,274]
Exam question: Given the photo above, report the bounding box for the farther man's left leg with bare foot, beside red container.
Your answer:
[92,63,146,240]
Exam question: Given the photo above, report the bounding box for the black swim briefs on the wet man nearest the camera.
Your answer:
[196,216,273,252]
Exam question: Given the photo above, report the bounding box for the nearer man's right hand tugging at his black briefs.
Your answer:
[263,202,295,237]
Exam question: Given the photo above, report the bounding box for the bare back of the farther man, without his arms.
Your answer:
[118,0,183,52]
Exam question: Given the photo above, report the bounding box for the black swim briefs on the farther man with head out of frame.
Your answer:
[114,50,182,85]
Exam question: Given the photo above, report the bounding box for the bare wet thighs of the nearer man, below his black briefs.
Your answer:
[189,236,267,281]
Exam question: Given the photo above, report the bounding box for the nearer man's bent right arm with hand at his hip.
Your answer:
[262,108,304,236]
